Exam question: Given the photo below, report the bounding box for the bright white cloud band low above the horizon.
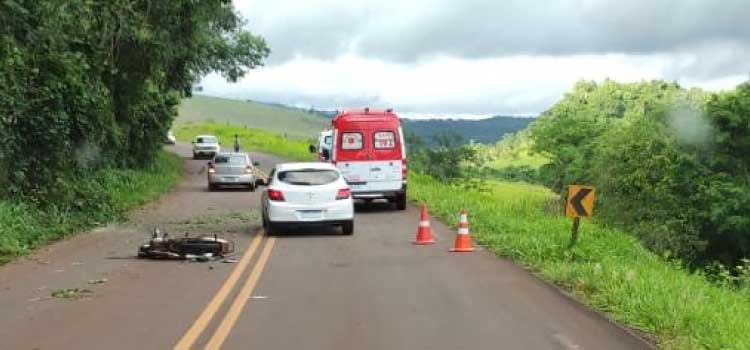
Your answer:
[198,54,745,115]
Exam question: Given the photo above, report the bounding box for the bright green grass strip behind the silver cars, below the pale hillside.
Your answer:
[174,123,315,161]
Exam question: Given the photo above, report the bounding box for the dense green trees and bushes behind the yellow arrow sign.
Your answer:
[531,81,750,266]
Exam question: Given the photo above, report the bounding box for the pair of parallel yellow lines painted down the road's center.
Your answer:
[174,234,276,350]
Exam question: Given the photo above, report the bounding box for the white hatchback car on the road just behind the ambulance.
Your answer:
[261,163,354,235]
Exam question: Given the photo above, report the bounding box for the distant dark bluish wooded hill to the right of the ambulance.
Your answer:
[402,116,534,143]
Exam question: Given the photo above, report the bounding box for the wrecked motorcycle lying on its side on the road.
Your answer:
[138,229,234,262]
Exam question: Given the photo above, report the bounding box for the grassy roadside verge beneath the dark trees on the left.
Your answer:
[0,152,182,264]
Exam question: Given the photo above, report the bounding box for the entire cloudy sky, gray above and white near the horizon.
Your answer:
[202,0,750,117]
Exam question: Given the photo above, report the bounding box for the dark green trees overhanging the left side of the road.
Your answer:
[0,0,269,202]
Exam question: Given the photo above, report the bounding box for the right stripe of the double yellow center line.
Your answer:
[206,237,276,350]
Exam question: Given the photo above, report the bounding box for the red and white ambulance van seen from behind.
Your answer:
[331,108,407,210]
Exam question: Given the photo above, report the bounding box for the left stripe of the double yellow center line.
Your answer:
[174,234,263,350]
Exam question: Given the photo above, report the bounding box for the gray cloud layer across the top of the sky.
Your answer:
[238,0,750,64]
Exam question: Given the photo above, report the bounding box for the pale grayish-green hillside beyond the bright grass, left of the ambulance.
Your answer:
[175,95,330,137]
